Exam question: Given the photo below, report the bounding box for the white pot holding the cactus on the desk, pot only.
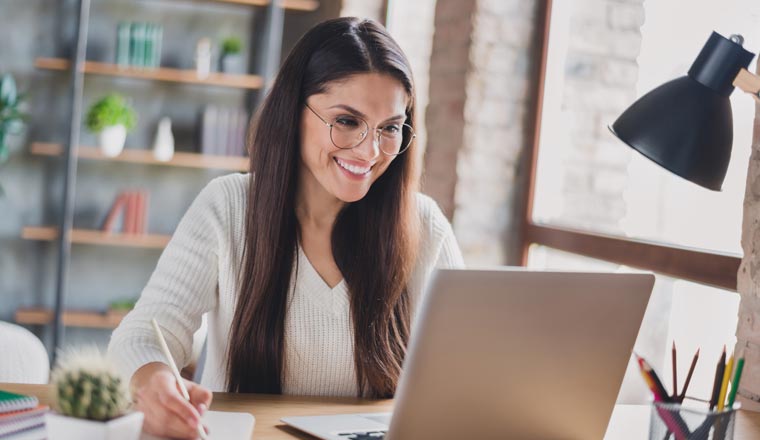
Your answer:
[45,412,144,440]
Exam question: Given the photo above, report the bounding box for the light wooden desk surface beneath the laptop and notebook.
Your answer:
[0,383,760,440]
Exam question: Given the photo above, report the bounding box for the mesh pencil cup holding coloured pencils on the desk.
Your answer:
[649,402,740,440]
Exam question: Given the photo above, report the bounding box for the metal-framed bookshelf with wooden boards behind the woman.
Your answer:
[15,0,324,362]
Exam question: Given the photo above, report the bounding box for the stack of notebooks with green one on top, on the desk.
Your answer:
[0,390,50,439]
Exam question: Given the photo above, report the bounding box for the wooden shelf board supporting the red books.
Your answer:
[21,226,171,249]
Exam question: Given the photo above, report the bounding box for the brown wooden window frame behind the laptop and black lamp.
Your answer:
[520,0,741,291]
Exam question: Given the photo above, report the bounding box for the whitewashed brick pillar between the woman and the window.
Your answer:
[424,0,541,265]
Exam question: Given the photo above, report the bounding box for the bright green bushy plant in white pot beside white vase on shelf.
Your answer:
[86,93,137,157]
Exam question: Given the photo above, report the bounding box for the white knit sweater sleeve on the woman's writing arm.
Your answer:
[108,180,226,380]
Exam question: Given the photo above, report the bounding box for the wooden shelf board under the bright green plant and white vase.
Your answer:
[30,142,248,171]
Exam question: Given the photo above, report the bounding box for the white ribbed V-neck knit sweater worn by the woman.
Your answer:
[108,174,463,396]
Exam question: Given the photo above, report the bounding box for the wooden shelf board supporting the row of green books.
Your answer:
[34,58,264,89]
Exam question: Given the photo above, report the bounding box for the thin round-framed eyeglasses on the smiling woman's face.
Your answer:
[306,104,417,156]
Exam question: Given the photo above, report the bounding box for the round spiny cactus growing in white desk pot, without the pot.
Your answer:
[52,348,130,421]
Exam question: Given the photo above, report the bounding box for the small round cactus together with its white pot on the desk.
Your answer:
[45,348,143,440]
